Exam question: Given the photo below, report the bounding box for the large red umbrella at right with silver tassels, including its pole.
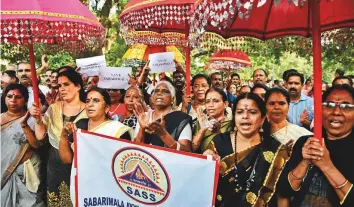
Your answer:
[191,0,354,141]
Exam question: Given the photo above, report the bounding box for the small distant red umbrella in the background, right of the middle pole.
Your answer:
[208,50,252,78]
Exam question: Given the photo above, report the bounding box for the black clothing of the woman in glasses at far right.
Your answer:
[277,130,354,207]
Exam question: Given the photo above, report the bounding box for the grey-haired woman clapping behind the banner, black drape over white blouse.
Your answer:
[135,81,192,151]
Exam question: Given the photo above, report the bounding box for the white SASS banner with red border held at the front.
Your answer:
[75,131,219,207]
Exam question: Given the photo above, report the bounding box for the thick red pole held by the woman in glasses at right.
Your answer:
[309,1,322,143]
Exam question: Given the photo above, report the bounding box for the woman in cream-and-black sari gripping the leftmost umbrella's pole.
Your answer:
[30,70,87,206]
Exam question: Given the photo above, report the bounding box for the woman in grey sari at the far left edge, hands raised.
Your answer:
[1,83,44,207]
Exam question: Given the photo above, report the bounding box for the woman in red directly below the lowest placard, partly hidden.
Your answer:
[106,88,127,121]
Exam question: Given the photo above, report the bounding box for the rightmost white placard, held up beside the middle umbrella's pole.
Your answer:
[149,52,176,73]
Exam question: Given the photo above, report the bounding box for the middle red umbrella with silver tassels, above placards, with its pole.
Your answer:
[119,0,195,94]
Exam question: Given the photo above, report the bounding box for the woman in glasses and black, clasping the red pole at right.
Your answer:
[278,85,354,207]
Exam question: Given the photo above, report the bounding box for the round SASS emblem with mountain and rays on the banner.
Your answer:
[112,147,170,205]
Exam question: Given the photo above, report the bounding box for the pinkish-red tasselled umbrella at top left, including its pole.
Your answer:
[0,0,105,106]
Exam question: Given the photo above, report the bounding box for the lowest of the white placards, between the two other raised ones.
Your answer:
[98,67,132,89]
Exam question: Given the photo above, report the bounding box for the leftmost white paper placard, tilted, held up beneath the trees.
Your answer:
[76,55,106,76]
